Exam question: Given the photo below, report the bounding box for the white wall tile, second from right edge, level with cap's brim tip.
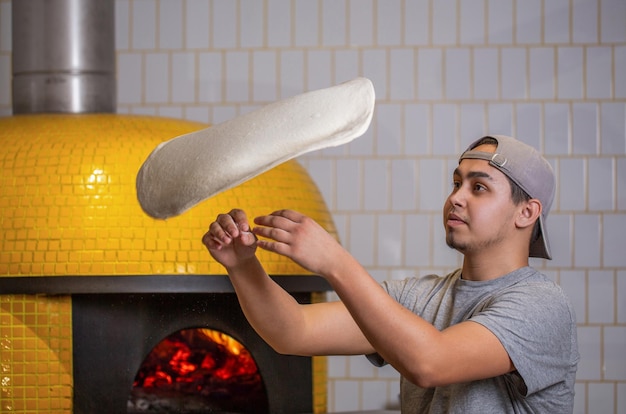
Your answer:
[568,215,601,268]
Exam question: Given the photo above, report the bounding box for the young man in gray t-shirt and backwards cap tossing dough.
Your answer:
[203,136,578,413]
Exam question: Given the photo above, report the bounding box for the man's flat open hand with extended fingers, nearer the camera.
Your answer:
[253,210,345,276]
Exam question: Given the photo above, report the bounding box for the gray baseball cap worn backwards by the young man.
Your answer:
[459,135,556,259]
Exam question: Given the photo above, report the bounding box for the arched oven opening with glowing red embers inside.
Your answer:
[128,329,268,413]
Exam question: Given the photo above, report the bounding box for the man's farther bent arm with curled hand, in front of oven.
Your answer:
[202,210,373,355]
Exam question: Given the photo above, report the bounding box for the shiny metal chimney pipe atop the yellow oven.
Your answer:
[11,0,116,114]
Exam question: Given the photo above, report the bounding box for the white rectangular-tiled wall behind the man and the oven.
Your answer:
[0,0,626,414]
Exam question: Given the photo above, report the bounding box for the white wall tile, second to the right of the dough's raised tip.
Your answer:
[404,103,431,155]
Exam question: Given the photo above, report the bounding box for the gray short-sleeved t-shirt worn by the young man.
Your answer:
[367,267,579,414]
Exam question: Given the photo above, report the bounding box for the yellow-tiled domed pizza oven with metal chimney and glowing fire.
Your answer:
[0,0,336,413]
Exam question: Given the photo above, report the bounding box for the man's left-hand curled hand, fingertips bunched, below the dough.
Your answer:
[202,209,257,269]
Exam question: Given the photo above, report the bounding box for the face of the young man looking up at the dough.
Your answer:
[443,145,516,254]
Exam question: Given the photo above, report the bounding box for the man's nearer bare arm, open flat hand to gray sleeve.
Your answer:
[254,210,514,387]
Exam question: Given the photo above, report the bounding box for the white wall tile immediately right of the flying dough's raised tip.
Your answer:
[374,104,402,155]
